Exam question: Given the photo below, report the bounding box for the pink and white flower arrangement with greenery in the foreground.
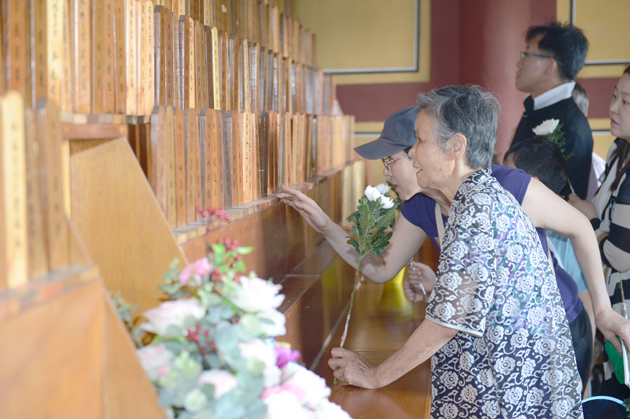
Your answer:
[114,213,350,419]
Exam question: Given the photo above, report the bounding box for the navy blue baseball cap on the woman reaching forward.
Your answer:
[354,106,420,160]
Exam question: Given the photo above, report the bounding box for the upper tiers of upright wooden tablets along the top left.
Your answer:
[0,0,326,115]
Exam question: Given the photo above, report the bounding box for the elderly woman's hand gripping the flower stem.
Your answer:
[328,348,379,389]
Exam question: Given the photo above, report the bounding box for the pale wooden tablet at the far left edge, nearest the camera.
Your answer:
[0,91,28,290]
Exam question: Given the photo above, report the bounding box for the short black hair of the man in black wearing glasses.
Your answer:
[525,22,588,80]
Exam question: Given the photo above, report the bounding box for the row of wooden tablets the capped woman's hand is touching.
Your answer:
[129,106,354,228]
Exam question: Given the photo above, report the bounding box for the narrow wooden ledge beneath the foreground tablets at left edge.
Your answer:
[0,265,100,322]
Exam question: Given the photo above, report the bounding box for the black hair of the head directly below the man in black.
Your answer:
[504,137,569,195]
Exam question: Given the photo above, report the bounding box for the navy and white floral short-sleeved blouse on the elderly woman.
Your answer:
[426,170,582,419]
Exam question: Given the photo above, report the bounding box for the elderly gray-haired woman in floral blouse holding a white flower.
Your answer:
[328,86,582,418]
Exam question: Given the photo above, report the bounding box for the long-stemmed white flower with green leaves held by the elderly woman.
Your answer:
[340,184,397,348]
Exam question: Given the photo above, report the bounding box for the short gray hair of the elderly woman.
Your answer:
[416,85,500,169]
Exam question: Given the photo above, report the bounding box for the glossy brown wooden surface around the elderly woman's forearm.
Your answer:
[313,280,431,419]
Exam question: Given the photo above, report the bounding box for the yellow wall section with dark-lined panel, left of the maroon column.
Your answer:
[296,0,431,84]
